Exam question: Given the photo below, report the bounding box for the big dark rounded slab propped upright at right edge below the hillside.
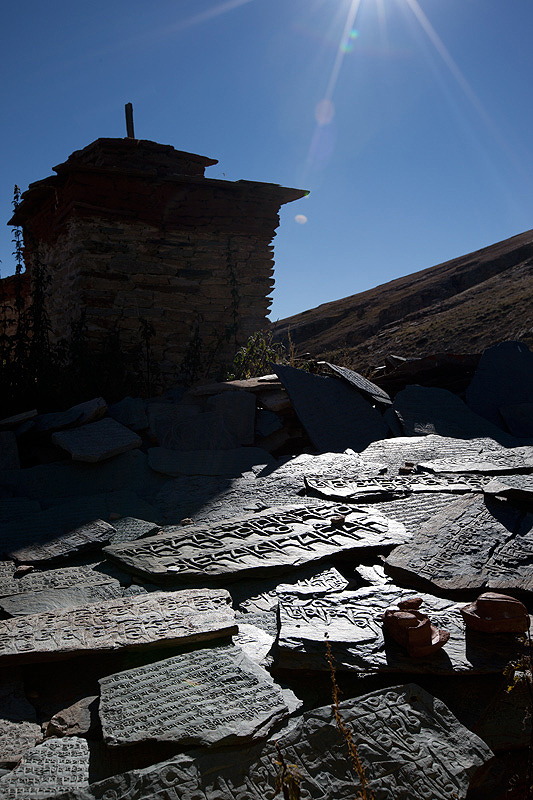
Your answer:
[466,342,533,425]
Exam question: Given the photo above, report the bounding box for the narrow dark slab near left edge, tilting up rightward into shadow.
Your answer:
[7,519,115,565]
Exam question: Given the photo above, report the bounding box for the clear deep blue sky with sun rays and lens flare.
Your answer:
[0,0,533,320]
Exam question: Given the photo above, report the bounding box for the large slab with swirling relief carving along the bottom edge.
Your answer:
[48,684,492,800]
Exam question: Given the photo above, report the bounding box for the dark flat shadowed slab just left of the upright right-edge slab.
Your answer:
[392,386,517,447]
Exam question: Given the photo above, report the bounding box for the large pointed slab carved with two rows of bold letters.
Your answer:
[105,504,406,584]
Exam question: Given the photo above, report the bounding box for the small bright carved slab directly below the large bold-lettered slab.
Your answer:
[230,564,348,611]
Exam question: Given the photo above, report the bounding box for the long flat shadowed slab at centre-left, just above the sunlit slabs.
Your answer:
[148,446,276,478]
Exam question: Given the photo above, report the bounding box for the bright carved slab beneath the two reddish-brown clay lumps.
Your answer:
[277,585,517,675]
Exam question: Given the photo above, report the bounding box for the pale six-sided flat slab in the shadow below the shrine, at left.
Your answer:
[52,417,142,463]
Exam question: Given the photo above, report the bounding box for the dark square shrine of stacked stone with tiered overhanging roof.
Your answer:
[12,139,305,383]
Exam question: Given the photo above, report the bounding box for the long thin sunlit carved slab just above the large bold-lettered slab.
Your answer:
[304,474,484,502]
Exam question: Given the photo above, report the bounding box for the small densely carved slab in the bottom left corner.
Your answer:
[0,737,89,800]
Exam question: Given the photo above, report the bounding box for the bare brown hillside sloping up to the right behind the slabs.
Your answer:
[273,230,533,369]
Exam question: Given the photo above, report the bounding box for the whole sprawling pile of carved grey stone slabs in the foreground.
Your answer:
[0,340,533,800]
